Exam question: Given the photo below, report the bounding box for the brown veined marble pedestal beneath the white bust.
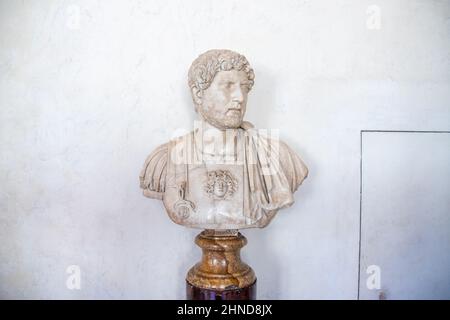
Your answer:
[186,230,256,300]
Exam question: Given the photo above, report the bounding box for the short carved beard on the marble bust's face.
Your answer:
[198,102,244,129]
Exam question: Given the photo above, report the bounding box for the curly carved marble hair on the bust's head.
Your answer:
[188,49,255,103]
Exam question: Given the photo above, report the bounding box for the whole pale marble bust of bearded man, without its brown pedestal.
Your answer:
[139,50,308,230]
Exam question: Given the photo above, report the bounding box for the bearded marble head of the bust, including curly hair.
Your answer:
[188,50,255,130]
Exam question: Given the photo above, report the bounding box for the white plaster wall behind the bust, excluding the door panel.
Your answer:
[0,0,450,299]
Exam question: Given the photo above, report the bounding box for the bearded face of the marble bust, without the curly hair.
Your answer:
[198,70,249,129]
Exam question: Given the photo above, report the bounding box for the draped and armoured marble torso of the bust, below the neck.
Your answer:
[141,124,308,230]
